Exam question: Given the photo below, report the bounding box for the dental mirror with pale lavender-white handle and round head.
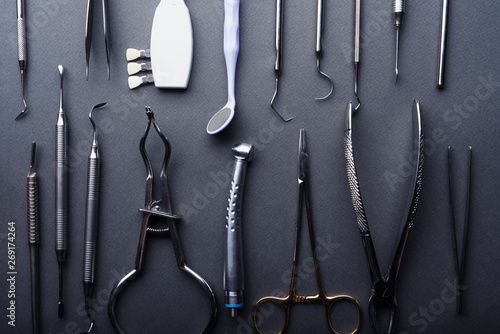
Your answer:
[207,0,240,135]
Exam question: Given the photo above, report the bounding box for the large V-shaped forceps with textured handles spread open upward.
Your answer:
[344,101,424,334]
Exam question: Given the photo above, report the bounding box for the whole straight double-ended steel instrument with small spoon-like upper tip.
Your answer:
[55,65,68,318]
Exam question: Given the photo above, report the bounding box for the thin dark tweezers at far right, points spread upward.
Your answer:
[448,146,472,314]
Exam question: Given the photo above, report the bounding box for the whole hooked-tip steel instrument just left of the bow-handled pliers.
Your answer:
[79,102,106,333]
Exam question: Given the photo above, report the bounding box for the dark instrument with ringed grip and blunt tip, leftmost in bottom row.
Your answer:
[26,142,40,334]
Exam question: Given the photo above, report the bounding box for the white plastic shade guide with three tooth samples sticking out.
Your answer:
[127,0,193,89]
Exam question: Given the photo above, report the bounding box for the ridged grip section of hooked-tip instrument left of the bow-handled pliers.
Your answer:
[83,157,101,283]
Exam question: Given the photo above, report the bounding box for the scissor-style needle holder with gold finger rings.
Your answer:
[252,129,361,334]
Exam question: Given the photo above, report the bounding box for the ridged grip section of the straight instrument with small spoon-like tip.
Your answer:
[56,125,68,250]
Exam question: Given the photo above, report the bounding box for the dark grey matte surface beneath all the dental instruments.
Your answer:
[0,0,500,334]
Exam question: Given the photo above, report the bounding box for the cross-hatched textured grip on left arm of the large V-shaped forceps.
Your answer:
[344,131,370,233]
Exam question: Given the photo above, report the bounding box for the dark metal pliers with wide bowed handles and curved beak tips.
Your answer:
[108,107,217,334]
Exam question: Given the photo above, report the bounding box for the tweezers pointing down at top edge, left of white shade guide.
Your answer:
[85,0,110,80]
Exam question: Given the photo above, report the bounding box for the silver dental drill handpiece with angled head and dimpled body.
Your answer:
[223,143,254,318]
